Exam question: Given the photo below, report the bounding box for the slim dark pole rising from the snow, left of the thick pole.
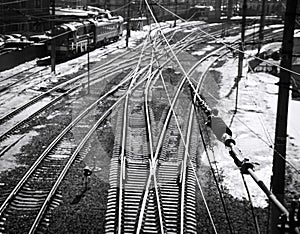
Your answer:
[234,0,247,113]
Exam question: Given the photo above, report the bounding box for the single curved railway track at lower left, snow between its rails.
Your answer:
[0,69,138,233]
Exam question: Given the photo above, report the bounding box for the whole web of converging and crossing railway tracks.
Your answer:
[0,5,298,233]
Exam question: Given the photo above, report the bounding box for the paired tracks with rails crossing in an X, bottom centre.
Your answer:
[105,29,227,233]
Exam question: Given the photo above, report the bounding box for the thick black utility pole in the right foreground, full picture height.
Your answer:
[271,0,298,234]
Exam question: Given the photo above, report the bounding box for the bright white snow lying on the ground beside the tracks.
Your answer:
[1,22,300,206]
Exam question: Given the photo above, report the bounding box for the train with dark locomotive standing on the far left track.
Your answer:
[47,16,124,59]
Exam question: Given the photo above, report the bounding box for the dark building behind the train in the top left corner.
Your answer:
[0,0,51,35]
